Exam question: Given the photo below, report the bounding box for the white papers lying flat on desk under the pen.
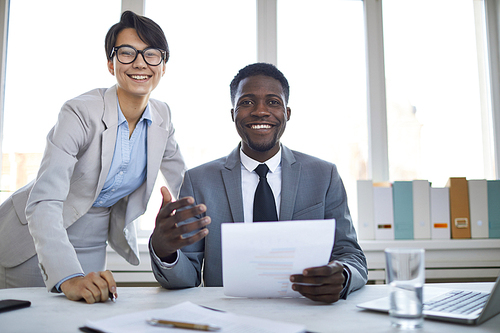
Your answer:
[86,302,305,333]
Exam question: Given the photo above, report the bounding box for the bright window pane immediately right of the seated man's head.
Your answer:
[278,0,368,221]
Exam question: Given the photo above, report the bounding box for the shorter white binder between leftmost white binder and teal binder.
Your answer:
[373,186,394,240]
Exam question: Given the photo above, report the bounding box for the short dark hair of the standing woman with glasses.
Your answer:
[104,10,170,62]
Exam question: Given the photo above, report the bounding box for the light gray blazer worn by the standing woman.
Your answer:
[0,86,185,290]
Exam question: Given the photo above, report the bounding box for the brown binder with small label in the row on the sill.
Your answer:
[446,177,470,238]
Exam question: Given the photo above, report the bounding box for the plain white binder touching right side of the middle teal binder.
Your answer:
[412,180,431,239]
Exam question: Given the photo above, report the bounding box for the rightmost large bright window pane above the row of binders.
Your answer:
[383,0,494,186]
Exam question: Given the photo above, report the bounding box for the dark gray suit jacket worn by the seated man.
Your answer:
[152,146,367,295]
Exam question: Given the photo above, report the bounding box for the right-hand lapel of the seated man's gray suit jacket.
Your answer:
[279,146,301,221]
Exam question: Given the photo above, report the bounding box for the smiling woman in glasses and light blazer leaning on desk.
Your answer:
[0,11,185,303]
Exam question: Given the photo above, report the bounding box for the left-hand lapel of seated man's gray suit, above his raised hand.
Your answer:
[221,145,244,222]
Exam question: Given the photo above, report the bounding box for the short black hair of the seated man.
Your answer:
[229,62,290,106]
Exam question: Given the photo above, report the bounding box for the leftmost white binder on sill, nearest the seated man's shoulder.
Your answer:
[357,180,375,240]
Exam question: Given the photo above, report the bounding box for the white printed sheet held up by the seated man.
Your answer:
[221,219,335,298]
